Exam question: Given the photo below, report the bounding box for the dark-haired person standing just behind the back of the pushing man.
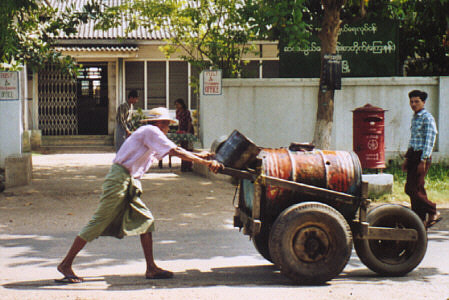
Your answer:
[115,90,139,152]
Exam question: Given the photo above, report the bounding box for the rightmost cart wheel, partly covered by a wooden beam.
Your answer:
[354,204,427,276]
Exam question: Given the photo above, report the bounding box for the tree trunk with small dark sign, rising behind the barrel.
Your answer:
[313,0,344,149]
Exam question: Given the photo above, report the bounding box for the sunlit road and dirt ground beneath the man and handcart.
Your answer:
[0,154,449,300]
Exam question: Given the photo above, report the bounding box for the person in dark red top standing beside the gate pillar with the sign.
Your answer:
[175,98,195,172]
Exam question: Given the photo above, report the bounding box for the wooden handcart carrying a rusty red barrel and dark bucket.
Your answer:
[212,131,427,284]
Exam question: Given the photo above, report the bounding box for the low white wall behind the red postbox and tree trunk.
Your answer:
[200,77,449,160]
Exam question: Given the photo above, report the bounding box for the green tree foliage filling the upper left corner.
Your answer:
[0,0,98,72]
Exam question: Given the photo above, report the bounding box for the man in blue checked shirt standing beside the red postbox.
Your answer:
[402,90,441,228]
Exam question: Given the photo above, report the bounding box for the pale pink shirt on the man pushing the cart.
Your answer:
[113,125,177,178]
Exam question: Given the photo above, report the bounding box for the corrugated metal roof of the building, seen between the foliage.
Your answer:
[48,0,170,40]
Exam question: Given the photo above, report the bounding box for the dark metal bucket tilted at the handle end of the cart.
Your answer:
[215,130,260,169]
